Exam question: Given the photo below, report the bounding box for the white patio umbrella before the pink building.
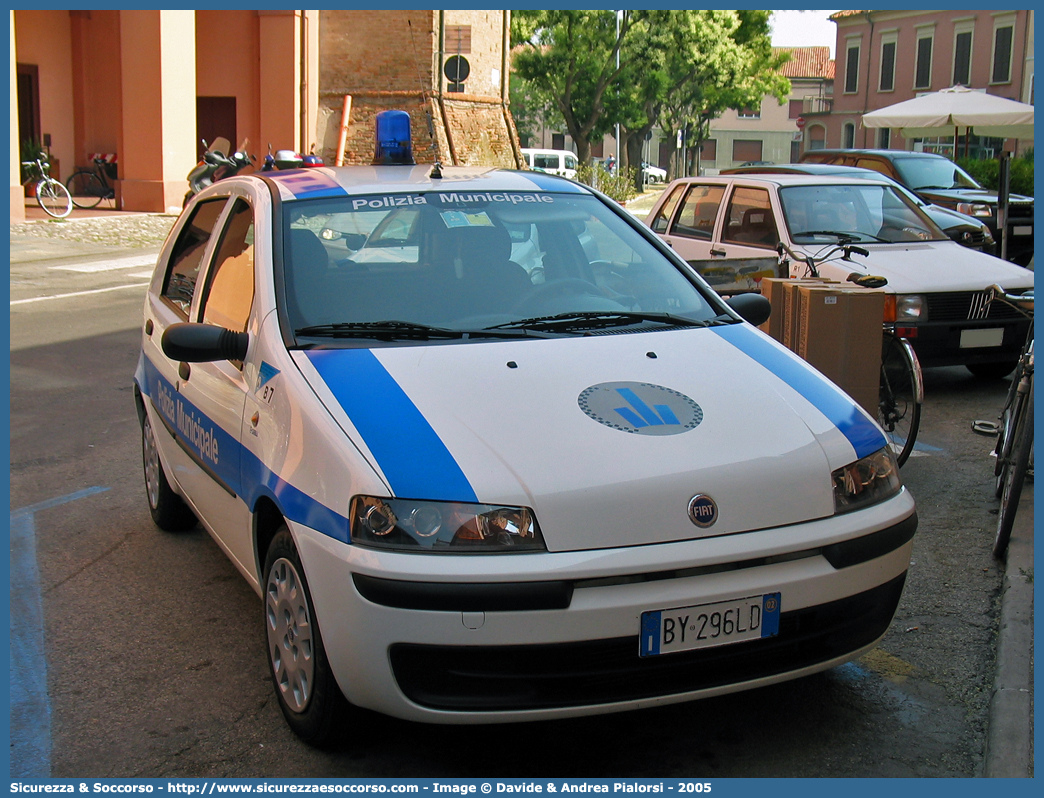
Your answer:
[862,86,1034,139]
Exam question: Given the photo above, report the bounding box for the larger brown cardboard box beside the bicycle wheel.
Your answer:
[792,284,885,418]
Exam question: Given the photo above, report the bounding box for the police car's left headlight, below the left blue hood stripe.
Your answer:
[351,496,547,554]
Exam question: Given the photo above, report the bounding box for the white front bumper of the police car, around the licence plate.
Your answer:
[294,491,917,723]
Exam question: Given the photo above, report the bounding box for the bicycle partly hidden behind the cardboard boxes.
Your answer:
[778,241,924,466]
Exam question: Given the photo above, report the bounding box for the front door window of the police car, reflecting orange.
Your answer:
[203,200,254,332]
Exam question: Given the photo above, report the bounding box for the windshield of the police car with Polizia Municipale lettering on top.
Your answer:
[283,191,723,344]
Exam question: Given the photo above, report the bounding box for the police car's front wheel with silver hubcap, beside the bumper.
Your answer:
[264,524,351,747]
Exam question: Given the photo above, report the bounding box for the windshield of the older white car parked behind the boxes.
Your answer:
[780,185,947,243]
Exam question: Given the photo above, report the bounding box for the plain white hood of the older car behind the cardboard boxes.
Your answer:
[801,240,1034,294]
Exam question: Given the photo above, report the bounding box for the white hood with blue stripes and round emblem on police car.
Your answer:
[294,324,884,551]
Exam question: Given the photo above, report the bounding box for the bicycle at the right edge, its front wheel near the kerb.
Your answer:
[990,285,1034,559]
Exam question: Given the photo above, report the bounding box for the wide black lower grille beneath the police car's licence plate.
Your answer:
[390,573,906,712]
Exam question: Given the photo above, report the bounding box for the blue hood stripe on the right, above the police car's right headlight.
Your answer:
[711,324,887,457]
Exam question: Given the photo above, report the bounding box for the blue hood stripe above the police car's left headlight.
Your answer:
[305,349,478,501]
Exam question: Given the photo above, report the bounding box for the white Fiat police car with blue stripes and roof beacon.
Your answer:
[135,112,917,743]
